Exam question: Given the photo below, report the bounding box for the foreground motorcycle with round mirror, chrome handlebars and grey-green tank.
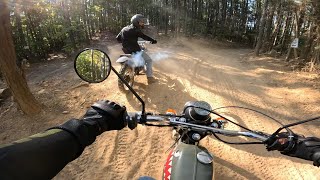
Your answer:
[75,49,320,180]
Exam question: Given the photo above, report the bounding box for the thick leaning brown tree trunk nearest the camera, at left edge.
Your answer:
[0,0,41,115]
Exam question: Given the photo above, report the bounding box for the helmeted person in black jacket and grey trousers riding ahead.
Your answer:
[116,14,157,83]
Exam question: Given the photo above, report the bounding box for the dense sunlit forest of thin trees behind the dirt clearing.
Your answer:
[4,0,320,67]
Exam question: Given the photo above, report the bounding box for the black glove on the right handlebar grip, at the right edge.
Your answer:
[267,133,320,167]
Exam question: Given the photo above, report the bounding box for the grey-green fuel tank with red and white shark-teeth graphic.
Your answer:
[163,143,213,180]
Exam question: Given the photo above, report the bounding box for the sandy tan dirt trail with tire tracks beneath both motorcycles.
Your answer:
[0,35,320,180]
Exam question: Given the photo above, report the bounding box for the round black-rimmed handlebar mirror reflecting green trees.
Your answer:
[74,49,111,83]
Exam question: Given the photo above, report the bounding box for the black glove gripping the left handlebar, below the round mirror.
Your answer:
[50,100,127,150]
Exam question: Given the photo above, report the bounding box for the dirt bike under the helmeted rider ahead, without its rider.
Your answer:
[116,41,151,92]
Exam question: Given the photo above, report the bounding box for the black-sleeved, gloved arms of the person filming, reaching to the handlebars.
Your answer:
[0,101,320,180]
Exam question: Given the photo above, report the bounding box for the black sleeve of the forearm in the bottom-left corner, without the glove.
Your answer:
[0,129,82,179]
